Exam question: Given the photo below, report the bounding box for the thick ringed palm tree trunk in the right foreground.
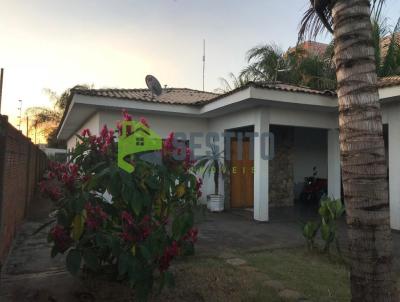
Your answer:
[332,0,398,302]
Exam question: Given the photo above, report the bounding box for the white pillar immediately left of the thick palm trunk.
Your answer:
[328,129,341,199]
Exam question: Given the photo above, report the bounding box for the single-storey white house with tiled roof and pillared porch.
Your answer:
[58,77,400,230]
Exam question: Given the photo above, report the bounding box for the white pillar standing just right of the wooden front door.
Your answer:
[254,108,269,221]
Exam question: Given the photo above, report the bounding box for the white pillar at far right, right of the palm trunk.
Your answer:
[388,108,400,230]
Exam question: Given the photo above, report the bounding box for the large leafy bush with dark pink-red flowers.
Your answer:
[40,112,201,300]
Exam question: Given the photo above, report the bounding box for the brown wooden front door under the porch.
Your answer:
[230,139,254,208]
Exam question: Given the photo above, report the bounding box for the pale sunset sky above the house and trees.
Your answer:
[0,0,400,124]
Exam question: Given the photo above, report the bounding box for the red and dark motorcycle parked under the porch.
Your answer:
[300,167,328,204]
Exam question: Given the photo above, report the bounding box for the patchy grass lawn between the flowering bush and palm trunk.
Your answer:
[153,248,350,302]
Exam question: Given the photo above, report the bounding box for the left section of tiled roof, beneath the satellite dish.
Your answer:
[72,88,218,105]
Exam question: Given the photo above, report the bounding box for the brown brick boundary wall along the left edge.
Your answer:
[0,115,47,266]
